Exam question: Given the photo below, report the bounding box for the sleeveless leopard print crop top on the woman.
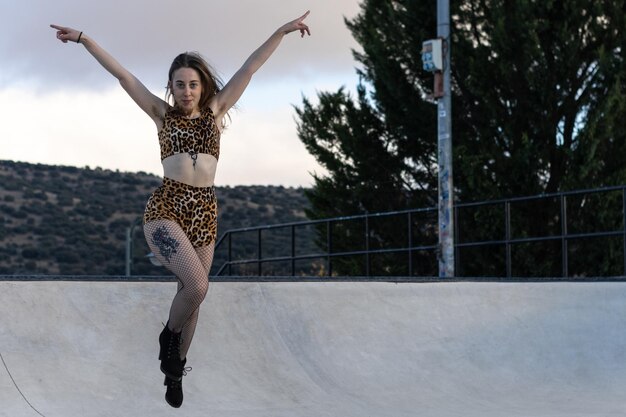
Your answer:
[159,108,220,161]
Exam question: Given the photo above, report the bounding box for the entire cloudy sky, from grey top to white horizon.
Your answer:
[0,0,359,187]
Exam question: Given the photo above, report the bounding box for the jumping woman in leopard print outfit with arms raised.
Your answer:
[50,11,310,407]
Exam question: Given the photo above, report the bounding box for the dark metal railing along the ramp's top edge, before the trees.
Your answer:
[213,186,626,278]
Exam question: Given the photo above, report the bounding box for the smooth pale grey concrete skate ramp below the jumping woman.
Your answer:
[0,282,626,417]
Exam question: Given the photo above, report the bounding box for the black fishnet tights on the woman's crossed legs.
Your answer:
[144,220,215,359]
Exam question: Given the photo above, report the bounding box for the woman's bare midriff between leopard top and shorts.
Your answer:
[161,153,217,187]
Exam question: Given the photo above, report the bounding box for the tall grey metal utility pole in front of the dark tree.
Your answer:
[437,0,454,278]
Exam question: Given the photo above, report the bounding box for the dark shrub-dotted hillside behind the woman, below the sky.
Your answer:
[0,161,313,275]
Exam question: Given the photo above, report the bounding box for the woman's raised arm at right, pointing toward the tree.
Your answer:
[211,11,311,120]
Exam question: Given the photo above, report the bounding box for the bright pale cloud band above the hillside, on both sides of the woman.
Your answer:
[0,80,334,186]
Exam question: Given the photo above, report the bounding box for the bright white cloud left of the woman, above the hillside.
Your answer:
[0,89,159,173]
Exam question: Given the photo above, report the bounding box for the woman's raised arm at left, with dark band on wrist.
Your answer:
[50,25,167,126]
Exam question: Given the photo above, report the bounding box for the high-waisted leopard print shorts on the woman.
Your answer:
[143,177,217,248]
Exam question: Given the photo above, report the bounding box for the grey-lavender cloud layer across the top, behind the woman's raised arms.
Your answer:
[0,0,358,89]
